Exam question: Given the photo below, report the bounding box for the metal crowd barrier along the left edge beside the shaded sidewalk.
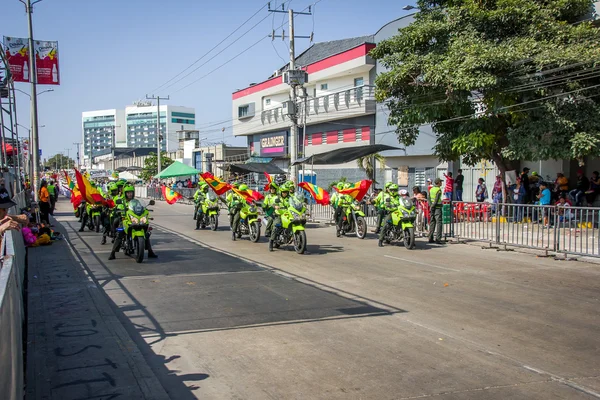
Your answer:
[0,193,26,400]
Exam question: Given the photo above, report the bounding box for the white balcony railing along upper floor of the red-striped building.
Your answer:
[260,85,375,125]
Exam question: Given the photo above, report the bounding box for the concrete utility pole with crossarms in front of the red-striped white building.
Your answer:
[269,3,313,183]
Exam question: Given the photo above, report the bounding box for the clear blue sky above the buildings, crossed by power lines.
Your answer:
[0,0,415,158]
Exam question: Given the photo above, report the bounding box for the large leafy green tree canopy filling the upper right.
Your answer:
[371,0,600,172]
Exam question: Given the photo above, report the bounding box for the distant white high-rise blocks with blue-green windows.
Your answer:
[82,102,196,166]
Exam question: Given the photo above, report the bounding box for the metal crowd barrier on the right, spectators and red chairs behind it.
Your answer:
[445,202,600,257]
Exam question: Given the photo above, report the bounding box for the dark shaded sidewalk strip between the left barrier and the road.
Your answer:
[26,216,169,400]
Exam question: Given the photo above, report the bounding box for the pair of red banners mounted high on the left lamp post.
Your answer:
[4,36,60,85]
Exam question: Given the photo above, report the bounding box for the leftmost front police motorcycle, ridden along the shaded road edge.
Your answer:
[117,199,156,263]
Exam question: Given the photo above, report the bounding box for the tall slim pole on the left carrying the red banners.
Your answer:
[19,0,42,201]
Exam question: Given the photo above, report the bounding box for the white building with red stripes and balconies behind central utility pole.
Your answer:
[232,36,376,185]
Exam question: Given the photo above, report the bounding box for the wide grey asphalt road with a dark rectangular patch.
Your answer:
[58,203,600,399]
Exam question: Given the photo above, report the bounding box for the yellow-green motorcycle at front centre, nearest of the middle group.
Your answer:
[273,193,306,254]
